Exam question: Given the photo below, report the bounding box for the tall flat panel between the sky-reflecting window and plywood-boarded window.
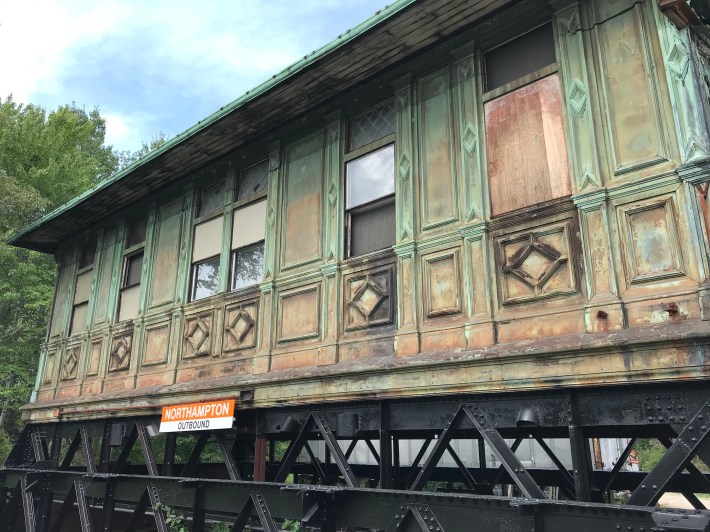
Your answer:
[419,68,456,228]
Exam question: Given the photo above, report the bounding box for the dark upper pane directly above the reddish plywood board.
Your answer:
[485,24,557,91]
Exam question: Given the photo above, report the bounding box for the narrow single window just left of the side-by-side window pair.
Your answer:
[118,218,148,321]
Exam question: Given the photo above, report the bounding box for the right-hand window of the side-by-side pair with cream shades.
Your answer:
[230,161,269,290]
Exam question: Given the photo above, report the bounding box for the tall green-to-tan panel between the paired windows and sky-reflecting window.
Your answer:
[282,131,323,267]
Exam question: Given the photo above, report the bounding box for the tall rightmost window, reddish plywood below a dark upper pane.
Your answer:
[483,23,571,215]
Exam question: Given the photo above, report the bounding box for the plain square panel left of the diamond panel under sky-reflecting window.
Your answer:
[278,285,320,342]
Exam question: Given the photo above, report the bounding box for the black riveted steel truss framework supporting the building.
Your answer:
[0,383,710,532]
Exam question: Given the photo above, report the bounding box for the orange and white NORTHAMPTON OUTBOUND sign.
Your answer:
[160,399,235,432]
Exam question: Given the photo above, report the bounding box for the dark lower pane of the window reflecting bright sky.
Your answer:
[350,198,395,257]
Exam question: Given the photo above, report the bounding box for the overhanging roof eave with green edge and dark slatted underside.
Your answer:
[8,0,515,253]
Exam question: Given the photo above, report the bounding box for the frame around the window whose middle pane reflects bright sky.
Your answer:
[342,98,397,260]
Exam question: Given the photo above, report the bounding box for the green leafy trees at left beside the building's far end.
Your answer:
[0,97,165,463]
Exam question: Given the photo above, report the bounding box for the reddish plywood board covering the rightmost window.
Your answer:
[485,74,571,214]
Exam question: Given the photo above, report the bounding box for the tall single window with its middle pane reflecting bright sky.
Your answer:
[345,101,395,257]
